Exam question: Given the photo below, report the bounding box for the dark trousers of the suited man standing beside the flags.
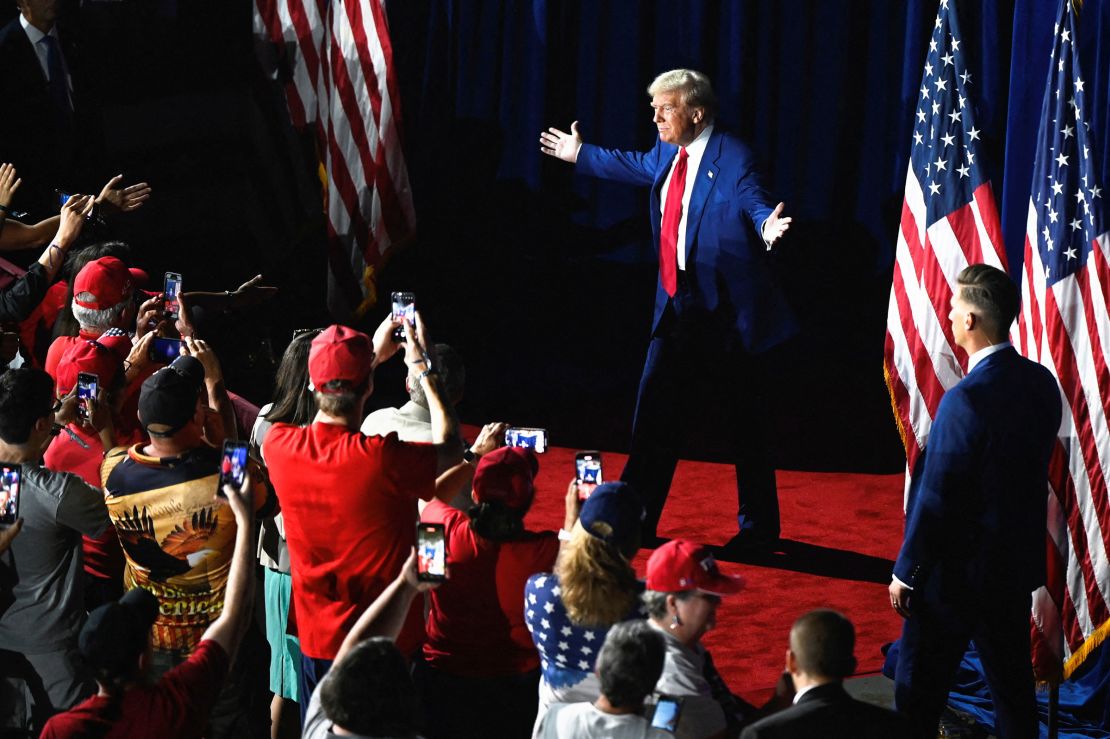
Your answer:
[895,591,1040,739]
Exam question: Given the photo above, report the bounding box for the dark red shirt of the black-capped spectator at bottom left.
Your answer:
[40,639,229,739]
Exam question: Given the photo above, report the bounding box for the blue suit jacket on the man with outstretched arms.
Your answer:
[577,129,797,353]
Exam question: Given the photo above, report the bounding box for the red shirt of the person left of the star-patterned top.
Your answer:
[421,500,558,677]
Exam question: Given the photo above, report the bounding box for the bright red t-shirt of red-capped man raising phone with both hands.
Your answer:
[262,423,435,659]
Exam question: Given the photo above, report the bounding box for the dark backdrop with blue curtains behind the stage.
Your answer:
[0,0,1110,474]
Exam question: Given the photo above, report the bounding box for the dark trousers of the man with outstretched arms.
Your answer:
[620,297,779,538]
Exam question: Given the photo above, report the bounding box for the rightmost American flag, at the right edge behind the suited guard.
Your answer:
[1012,0,1110,678]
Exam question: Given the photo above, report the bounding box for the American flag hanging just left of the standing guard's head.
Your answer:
[884,0,1006,489]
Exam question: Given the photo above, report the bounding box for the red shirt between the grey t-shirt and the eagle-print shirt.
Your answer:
[42,424,139,583]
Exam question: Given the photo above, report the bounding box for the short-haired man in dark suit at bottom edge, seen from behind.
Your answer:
[740,609,910,739]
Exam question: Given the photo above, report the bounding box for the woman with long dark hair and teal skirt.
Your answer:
[251,328,320,739]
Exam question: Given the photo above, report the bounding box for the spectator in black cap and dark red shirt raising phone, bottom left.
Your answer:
[42,468,258,739]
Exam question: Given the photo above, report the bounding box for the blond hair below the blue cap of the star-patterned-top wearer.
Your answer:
[555,522,639,626]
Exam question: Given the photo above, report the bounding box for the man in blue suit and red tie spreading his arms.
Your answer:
[539,70,796,548]
